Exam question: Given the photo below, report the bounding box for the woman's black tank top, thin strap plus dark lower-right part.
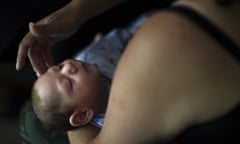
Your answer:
[161,6,240,144]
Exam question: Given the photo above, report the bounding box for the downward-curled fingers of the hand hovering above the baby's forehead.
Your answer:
[16,33,54,74]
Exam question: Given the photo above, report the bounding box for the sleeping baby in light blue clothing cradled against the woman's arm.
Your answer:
[32,14,148,131]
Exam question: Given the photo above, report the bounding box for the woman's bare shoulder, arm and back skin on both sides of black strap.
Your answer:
[86,1,240,144]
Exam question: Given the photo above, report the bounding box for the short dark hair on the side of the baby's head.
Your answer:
[32,88,75,131]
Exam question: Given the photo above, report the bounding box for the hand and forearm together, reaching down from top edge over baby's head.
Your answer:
[16,0,126,75]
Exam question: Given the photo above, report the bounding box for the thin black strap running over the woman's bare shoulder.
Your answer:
[166,6,240,62]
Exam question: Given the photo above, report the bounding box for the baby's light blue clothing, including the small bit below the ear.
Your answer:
[76,13,149,128]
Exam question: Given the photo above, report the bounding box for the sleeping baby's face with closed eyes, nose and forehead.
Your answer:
[34,59,102,108]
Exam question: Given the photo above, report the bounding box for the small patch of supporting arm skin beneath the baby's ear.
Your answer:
[67,124,100,144]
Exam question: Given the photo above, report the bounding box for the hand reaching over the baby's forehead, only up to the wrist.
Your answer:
[16,1,80,75]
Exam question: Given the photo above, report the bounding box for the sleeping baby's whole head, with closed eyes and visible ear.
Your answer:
[32,60,108,131]
